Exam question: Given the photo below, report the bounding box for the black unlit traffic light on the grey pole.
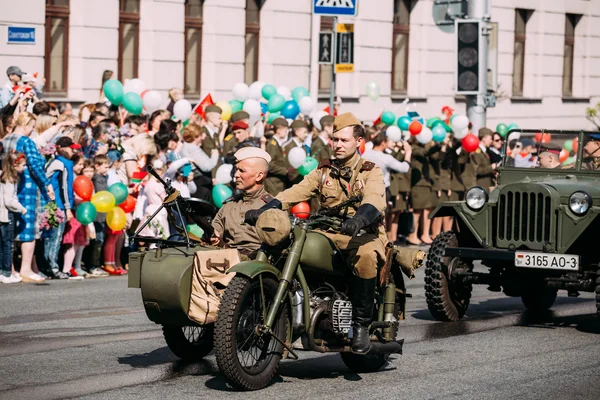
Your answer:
[455,19,487,94]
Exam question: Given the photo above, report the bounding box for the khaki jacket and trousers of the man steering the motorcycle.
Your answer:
[276,153,388,279]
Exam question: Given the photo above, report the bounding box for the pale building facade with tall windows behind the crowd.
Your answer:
[0,0,600,129]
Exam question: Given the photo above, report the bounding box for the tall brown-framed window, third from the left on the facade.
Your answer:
[184,0,204,96]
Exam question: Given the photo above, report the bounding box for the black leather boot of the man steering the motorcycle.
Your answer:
[352,277,376,355]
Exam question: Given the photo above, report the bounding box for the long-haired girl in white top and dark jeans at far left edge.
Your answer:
[0,151,27,283]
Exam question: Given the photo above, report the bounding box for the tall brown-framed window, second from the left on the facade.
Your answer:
[118,0,140,82]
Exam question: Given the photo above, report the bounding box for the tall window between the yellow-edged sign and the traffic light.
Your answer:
[392,0,411,94]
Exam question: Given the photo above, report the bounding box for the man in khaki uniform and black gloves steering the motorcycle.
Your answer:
[245,113,388,354]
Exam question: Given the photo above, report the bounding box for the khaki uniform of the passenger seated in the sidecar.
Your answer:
[212,187,273,255]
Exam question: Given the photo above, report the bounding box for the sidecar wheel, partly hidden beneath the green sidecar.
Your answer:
[163,324,213,361]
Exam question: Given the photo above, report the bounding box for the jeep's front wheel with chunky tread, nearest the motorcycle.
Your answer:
[425,232,473,321]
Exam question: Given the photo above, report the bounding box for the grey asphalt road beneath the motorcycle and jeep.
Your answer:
[0,262,600,400]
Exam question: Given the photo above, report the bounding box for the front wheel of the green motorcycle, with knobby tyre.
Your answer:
[215,276,288,390]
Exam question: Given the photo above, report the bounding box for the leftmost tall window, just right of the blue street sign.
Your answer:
[44,0,70,96]
